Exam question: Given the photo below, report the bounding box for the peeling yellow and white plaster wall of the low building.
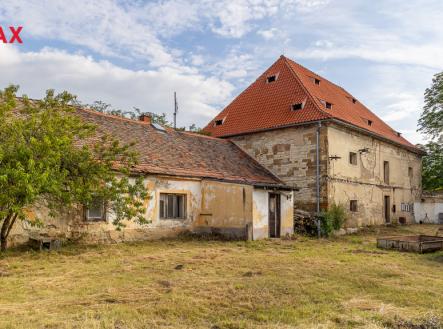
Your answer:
[10,176,292,244]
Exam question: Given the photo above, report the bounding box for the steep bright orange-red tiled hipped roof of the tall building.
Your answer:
[205,56,421,152]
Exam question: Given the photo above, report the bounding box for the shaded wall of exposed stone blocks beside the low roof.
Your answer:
[231,125,328,211]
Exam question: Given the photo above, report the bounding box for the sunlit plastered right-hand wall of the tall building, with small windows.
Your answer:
[327,125,421,227]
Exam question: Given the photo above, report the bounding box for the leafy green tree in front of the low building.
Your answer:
[0,86,147,250]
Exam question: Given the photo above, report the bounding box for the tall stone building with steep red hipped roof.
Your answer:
[205,56,423,227]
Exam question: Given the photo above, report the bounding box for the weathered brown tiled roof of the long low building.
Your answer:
[76,109,285,187]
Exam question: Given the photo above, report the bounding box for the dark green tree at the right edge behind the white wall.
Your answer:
[418,72,443,191]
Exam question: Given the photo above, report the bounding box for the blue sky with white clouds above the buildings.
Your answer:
[0,0,443,143]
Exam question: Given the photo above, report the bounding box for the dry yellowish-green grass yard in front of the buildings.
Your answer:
[0,225,443,329]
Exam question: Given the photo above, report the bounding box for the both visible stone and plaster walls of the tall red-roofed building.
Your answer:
[231,124,421,227]
